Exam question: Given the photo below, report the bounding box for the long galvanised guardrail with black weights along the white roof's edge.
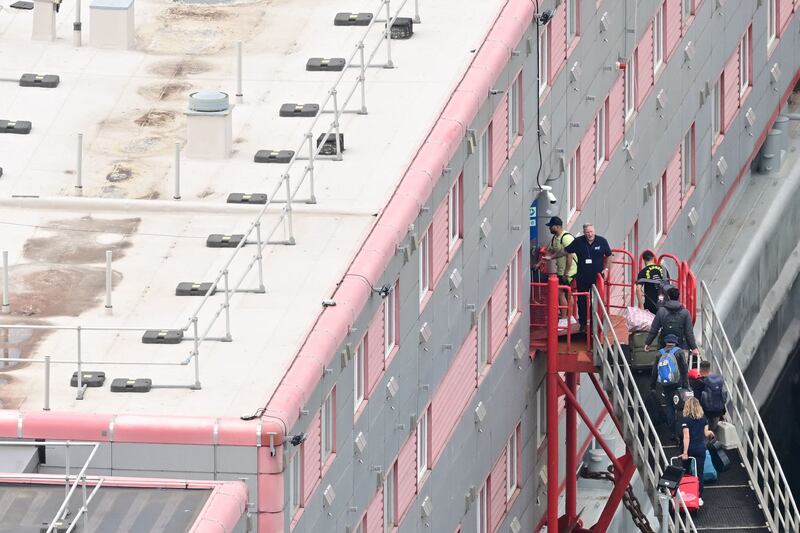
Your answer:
[0,0,420,409]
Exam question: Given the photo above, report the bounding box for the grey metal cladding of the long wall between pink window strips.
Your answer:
[287,0,798,532]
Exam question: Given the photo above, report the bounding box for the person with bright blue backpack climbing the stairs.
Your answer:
[650,334,689,437]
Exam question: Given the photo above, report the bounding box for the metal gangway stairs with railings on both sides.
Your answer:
[591,284,800,533]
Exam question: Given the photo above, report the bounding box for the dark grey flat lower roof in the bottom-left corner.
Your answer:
[0,484,211,533]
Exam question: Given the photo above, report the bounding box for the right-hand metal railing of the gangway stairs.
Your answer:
[700,282,800,533]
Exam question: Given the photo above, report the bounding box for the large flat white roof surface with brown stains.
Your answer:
[0,0,504,416]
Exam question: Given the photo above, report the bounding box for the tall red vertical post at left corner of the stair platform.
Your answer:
[546,276,556,532]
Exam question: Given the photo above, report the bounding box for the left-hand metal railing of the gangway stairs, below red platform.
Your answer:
[592,287,697,532]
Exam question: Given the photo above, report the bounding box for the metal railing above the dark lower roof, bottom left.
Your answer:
[0,441,105,533]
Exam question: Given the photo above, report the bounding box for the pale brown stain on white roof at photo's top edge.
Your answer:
[137,0,271,55]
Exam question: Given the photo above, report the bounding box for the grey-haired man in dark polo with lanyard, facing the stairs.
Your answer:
[549,223,613,332]
